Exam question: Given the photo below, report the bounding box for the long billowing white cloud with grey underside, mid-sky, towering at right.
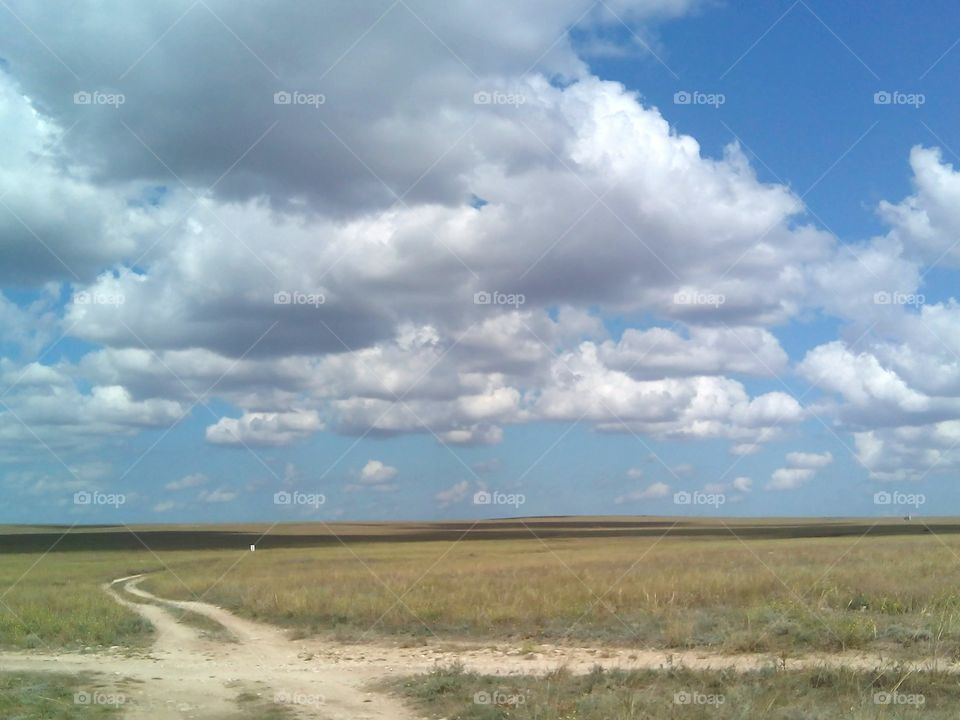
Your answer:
[68,78,830,372]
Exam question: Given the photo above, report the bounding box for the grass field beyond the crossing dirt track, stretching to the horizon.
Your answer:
[0,518,960,658]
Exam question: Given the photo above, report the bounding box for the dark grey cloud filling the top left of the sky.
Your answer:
[0,0,693,213]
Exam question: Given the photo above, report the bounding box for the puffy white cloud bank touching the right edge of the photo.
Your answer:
[798,146,960,480]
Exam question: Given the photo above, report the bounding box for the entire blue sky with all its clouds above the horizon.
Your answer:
[0,0,960,524]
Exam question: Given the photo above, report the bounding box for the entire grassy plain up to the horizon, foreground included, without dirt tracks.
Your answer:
[0,519,960,720]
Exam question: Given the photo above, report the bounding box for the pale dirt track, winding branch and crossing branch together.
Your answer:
[0,575,960,720]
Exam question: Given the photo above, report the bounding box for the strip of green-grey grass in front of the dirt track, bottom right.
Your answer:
[388,666,960,720]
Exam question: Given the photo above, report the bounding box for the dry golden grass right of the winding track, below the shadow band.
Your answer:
[139,535,960,656]
